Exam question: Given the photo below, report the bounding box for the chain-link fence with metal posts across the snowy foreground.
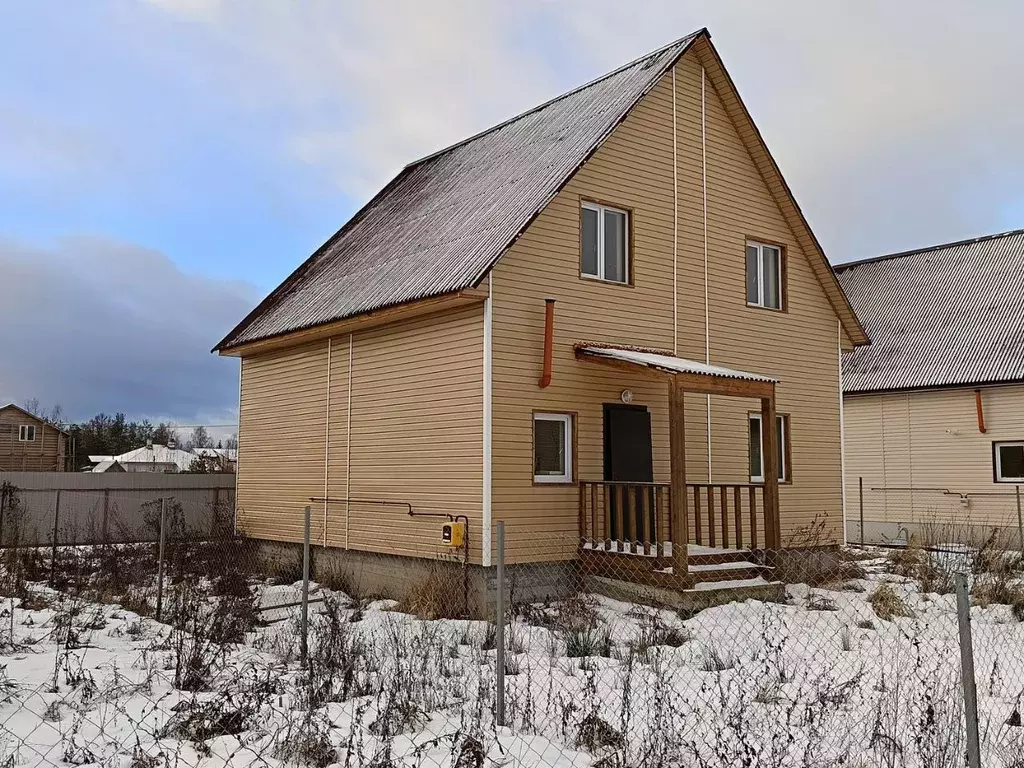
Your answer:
[0,495,1024,768]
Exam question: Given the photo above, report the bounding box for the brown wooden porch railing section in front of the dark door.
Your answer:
[580,480,672,557]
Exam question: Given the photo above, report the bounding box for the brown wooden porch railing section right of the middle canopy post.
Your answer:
[686,482,768,549]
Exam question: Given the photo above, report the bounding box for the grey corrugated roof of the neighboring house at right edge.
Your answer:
[836,230,1024,393]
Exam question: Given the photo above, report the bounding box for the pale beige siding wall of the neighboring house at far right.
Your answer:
[845,385,1024,537]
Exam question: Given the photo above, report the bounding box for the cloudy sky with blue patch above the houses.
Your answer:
[0,0,1024,424]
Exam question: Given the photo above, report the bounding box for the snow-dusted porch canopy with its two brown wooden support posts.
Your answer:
[575,343,780,572]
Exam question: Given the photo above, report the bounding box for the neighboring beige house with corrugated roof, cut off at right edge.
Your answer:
[837,230,1024,541]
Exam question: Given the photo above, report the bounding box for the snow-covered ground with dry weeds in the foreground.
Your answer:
[0,558,1024,768]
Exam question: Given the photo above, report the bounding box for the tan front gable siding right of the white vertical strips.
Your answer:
[692,49,843,545]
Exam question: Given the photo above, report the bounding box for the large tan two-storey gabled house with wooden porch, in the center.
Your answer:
[216,31,867,606]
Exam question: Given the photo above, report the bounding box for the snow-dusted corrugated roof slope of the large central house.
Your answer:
[211,30,705,349]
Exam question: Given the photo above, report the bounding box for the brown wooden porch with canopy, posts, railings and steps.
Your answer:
[577,345,780,589]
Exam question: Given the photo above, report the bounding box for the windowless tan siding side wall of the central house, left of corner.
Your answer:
[239,305,483,561]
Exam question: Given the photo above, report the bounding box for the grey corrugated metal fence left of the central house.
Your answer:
[0,472,234,547]
